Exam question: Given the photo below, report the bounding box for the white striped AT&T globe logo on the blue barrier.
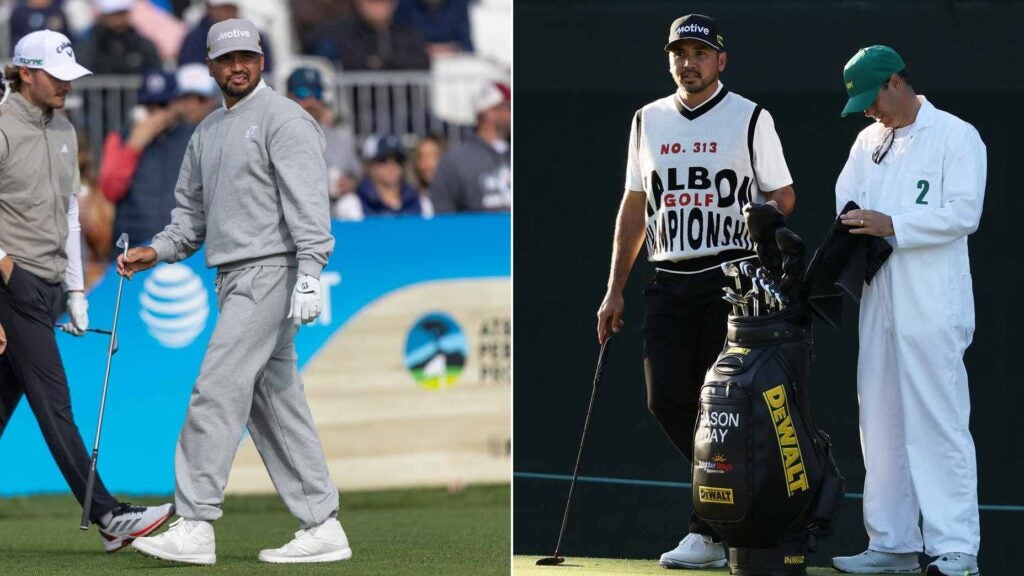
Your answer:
[139,263,210,348]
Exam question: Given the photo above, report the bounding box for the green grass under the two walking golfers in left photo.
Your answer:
[0,485,511,576]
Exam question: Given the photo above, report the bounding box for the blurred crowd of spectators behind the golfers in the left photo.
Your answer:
[8,0,511,286]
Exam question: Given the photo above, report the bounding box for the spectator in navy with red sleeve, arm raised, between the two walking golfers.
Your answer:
[98,71,195,243]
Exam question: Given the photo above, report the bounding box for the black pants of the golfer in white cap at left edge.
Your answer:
[0,265,118,522]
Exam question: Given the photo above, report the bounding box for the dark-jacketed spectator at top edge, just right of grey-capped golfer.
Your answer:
[313,0,430,70]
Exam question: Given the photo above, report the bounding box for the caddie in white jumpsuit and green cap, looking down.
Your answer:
[833,46,986,576]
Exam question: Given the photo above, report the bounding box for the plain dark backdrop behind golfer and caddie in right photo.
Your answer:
[513,0,1024,575]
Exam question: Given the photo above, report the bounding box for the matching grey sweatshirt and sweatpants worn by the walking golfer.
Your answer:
[152,72,338,529]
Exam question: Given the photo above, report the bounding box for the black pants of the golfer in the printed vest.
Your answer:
[643,269,729,540]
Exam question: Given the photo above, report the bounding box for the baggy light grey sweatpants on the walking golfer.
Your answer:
[174,266,338,529]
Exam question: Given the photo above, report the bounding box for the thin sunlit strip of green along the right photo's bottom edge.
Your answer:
[512,556,892,576]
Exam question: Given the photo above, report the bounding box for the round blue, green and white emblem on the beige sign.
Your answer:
[406,313,469,389]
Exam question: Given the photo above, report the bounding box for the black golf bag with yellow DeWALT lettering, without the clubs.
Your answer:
[692,303,845,576]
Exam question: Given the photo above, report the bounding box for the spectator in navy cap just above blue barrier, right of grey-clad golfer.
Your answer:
[355,134,433,217]
